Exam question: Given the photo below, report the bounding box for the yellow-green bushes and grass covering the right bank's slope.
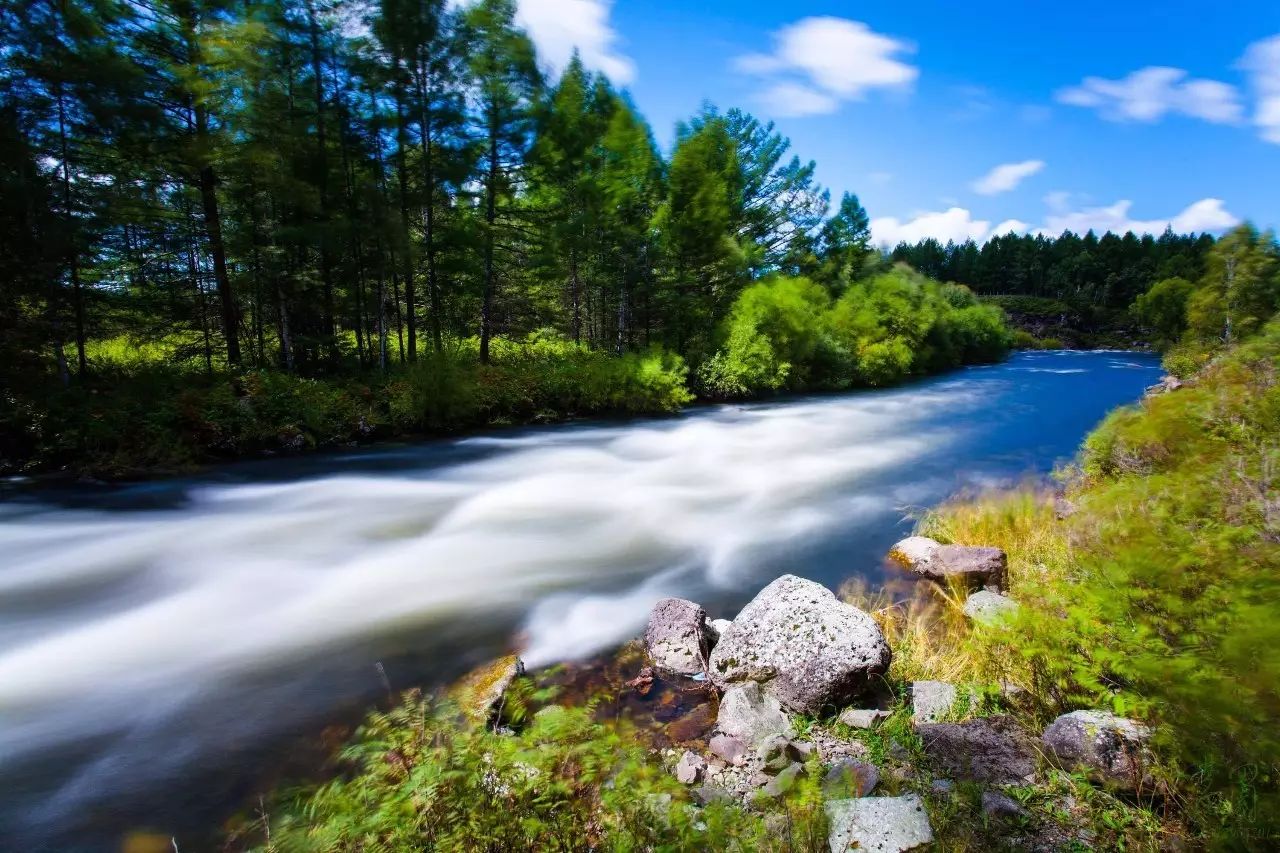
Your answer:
[915,321,1280,849]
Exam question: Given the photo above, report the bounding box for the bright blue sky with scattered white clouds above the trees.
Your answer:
[521,0,1280,242]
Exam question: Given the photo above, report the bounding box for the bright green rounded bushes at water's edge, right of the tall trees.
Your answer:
[698,268,1012,397]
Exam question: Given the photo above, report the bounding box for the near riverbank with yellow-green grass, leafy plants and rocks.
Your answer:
[241,325,1280,850]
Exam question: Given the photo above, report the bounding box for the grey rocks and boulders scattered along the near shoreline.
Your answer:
[470,537,1151,852]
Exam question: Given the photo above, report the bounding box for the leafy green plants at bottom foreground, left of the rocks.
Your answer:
[251,695,826,853]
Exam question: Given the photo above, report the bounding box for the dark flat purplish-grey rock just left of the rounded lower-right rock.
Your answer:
[915,716,1037,785]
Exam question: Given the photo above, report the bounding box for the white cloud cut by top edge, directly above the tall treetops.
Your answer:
[516,0,636,86]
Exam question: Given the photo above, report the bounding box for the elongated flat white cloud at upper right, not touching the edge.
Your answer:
[1056,65,1244,124]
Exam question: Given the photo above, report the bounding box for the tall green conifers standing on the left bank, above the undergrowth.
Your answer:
[0,0,869,384]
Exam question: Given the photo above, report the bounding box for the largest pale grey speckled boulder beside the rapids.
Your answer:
[710,575,891,713]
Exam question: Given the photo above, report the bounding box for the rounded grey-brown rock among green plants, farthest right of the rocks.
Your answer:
[1042,711,1151,790]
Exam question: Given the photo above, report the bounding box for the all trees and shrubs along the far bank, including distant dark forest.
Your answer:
[0,0,1239,475]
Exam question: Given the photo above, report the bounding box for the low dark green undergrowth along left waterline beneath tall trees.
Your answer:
[0,336,692,475]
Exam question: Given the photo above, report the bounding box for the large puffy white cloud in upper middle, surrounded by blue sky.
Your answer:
[733,15,920,115]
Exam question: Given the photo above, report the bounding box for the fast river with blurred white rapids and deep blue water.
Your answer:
[0,352,1158,850]
